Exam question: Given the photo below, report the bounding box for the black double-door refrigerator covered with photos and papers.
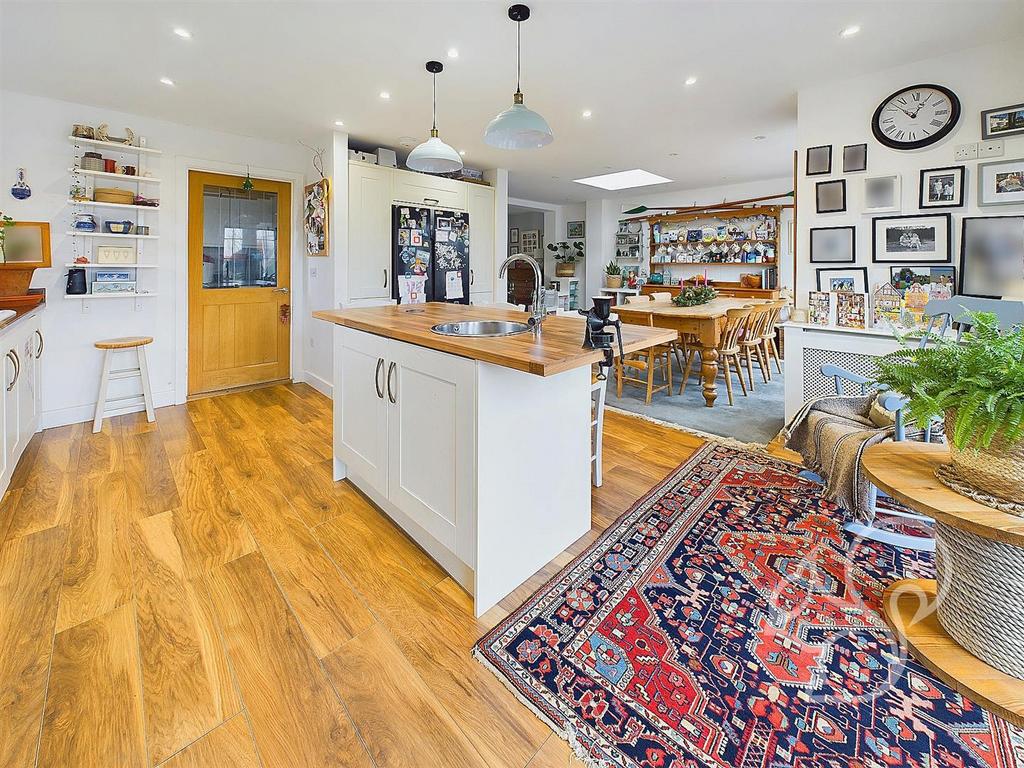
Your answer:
[391,205,469,304]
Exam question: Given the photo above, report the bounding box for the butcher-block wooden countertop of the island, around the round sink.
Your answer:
[313,302,677,376]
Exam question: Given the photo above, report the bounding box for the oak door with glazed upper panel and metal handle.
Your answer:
[188,171,292,395]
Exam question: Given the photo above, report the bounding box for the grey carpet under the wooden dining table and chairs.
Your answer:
[607,362,785,443]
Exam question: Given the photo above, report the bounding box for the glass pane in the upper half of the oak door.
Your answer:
[203,184,278,288]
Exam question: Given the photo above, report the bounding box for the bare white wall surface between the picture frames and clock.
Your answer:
[797,38,1024,306]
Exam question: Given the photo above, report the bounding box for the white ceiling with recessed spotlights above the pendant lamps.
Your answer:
[6,0,1024,203]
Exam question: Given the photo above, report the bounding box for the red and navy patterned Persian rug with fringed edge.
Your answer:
[474,443,1024,768]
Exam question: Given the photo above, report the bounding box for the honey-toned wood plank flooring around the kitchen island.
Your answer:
[0,385,770,768]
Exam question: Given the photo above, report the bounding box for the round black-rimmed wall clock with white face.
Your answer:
[871,84,961,150]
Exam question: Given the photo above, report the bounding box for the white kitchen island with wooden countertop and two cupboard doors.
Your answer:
[313,303,676,615]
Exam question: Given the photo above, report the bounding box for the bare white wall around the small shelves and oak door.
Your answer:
[0,91,311,427]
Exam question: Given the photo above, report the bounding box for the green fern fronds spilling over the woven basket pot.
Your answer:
[876,312,1024,450]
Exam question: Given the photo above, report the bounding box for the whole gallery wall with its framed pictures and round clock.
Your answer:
[796,40,1024,325]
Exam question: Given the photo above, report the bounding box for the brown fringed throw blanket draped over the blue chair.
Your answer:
[780,394,896,524]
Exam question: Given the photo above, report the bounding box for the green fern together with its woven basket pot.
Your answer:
[876,312,1024,515]
